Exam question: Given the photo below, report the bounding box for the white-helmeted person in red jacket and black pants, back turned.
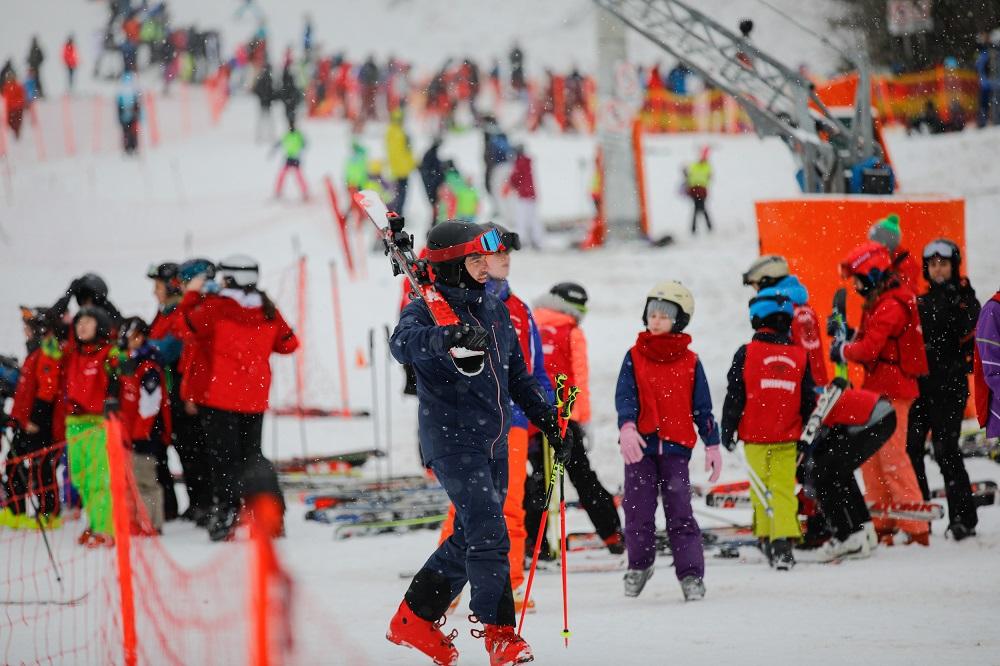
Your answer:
[180,255,299,541]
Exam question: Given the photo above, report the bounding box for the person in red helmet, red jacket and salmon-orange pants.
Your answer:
[830,241,930,546]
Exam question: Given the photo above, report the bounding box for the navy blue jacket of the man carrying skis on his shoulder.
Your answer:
[390,284,555,464]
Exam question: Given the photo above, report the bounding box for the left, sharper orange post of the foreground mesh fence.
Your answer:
[105,416,136,666]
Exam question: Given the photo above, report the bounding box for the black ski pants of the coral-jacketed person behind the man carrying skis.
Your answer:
[524,421,622,545]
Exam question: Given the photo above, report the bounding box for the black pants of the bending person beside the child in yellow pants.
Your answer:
[812,412,896,541]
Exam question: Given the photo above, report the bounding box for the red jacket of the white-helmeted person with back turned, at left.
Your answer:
[180,290,299,414]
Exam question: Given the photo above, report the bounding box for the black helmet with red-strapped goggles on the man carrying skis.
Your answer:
[427,220,503,289]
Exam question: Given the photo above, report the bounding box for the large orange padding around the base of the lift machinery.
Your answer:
[755,195,965,382]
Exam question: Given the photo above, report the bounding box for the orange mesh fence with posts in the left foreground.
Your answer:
[0,419,366,666]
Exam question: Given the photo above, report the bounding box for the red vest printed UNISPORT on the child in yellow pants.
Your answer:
[739,340,807,444]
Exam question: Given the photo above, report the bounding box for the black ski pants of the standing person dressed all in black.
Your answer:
[906,375,979,529]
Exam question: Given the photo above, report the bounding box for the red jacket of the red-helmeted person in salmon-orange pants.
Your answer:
[843,285,927,400]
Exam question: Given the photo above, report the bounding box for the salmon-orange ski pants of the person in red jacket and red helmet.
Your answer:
[861,398,929,535]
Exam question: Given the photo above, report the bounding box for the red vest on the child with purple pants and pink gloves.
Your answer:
[629,331,698,449]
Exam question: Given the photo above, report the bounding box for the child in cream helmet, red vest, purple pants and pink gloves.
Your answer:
[615,282,722,599]
